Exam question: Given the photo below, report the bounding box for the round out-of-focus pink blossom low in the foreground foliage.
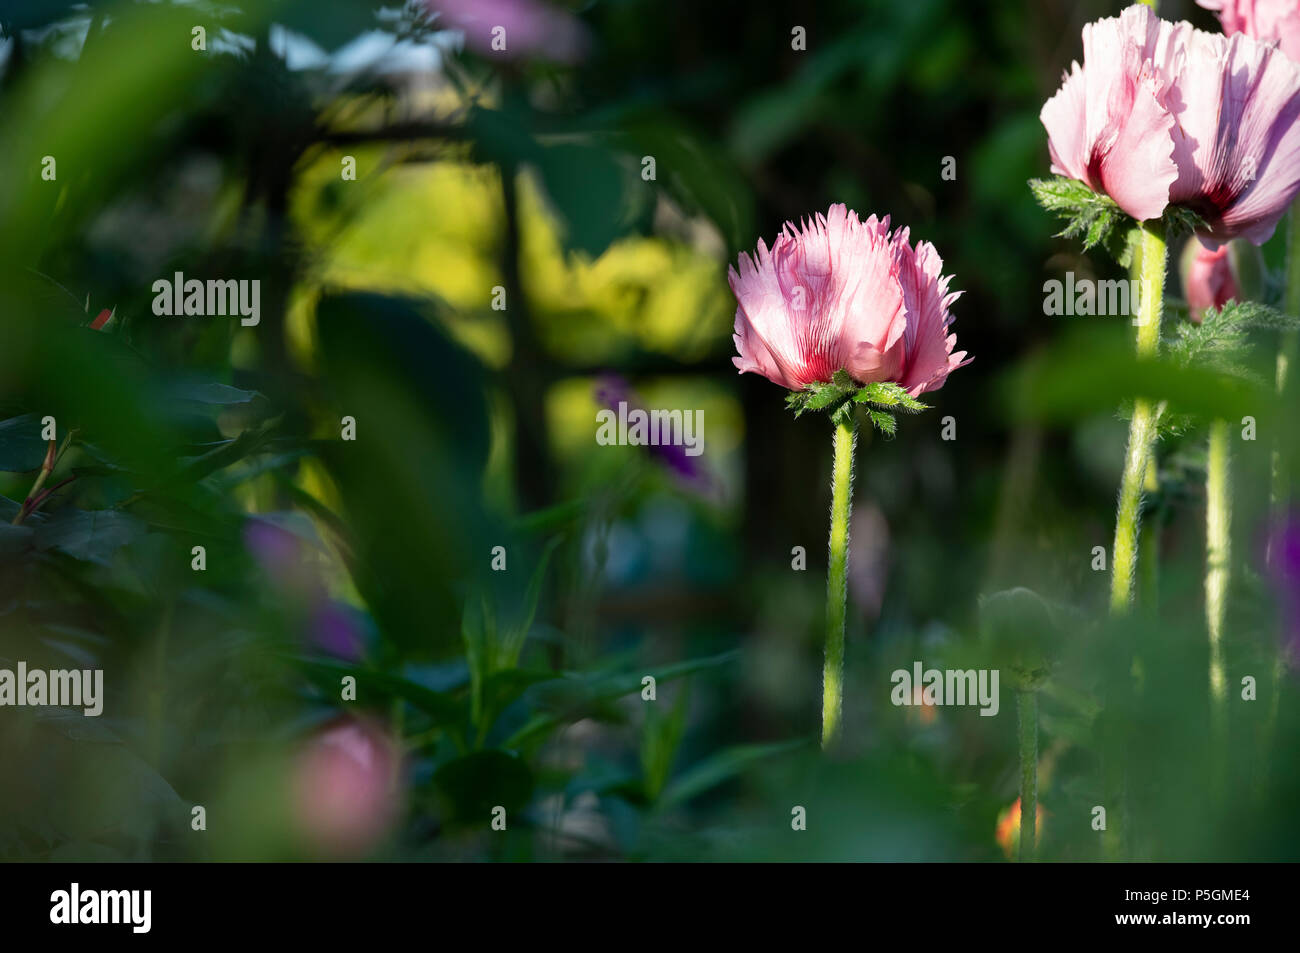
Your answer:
[291,718,400,857]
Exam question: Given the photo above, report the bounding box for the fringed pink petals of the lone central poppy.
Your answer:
[728,204,970,397]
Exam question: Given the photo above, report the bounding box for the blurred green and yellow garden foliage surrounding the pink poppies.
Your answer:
[0,0,1300,861]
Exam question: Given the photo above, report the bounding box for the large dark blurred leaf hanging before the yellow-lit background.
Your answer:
[316,294,493,654]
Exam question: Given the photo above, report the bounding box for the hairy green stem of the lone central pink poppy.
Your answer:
[822,412,858,748]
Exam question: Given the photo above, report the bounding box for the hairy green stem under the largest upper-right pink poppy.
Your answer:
[1110,221,1167,615]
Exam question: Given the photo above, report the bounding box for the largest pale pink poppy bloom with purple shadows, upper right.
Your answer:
[1040,5,1300,247]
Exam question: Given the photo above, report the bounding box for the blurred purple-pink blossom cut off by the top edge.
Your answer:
[428,0,590,62]
